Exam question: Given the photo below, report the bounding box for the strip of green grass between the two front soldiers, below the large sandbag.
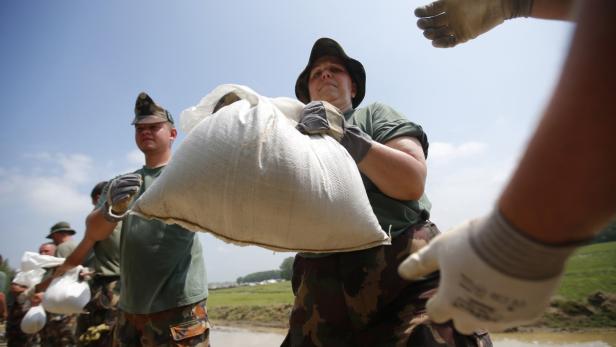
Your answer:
[207,281,293,309]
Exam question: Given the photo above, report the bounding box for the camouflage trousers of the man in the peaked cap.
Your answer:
[114,300,210,347]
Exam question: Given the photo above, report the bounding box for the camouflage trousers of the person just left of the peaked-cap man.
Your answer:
[76,276,120,347]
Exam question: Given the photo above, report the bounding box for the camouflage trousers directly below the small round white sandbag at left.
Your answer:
[39,311,77,347]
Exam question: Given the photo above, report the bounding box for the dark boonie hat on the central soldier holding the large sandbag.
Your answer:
[295,37,366,108]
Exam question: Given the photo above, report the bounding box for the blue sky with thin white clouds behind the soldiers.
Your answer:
[0,0,573,281]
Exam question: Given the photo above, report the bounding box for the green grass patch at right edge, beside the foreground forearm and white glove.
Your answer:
[558,242,616,301]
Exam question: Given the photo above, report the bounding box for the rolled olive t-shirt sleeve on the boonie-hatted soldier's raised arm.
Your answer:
[369,103,428,158]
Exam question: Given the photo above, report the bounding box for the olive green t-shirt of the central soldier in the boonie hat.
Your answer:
[344,103,431,237]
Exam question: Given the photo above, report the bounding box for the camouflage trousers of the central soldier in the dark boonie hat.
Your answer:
[282,222,492,347]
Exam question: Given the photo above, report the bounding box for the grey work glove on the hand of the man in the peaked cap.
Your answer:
[103,174,141,223]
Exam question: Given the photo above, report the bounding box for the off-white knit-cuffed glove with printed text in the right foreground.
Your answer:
[398,211,575,334]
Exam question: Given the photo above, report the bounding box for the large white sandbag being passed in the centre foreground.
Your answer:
[132,85,390,253]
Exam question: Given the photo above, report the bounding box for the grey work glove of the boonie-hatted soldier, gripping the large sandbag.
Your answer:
[296,101,372,163]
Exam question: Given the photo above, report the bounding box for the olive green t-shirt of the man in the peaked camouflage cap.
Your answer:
[119,167,208,314]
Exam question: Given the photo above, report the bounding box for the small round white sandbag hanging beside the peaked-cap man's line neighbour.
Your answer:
[43,265,90,314]
